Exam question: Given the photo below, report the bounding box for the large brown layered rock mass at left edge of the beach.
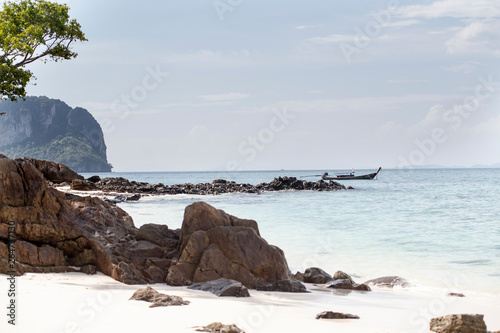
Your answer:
[0,155,178,284]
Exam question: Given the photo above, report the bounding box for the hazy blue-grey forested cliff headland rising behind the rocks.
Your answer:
[0,97,111,172]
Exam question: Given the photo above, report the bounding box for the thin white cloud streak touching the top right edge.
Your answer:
[400,0,500,19]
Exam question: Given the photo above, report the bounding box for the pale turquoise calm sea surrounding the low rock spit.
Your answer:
[84,168,500,299]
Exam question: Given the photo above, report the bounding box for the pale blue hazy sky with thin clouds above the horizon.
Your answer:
[18,0,500,171]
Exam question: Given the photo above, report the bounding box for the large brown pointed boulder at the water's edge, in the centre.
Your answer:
[167,202,305,289]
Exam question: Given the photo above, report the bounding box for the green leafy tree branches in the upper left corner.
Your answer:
[0,0,87,101]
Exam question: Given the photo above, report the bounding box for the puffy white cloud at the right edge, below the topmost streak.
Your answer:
[445,19,500,56]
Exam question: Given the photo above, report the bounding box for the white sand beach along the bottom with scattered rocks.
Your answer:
[0,273,500,333]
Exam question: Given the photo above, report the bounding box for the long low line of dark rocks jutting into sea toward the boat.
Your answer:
[87,176,352,195]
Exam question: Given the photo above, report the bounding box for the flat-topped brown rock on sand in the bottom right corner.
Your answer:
[430,314,487,333]
